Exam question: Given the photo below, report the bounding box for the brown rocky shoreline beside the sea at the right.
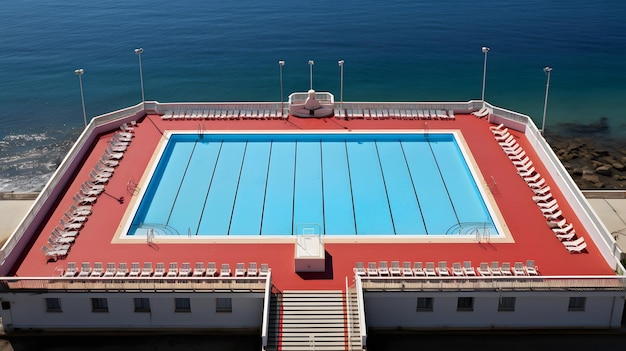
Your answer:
[545,134,626,190]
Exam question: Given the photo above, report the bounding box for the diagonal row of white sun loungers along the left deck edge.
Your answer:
[41,123,136,261]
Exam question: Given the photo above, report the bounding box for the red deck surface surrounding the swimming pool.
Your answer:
[13,114,614,290]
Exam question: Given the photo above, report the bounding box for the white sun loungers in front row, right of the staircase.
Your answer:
[353,260,539,277]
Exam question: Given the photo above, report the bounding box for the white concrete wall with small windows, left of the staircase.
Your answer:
[0,293,263,330]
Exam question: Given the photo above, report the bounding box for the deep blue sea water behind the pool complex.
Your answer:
[0,0,626,191]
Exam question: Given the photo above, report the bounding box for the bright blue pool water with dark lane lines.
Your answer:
[129,133,494,236]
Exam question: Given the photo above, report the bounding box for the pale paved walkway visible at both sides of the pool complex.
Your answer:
[0,191,626,258]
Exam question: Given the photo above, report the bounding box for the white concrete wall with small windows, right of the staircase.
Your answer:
[364,291,624,329]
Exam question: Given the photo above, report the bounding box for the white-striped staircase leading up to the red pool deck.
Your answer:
[267,290,361,351]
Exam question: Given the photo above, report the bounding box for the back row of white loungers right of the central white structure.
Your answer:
[335,109,455,120]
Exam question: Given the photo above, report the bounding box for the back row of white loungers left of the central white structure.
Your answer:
[161,109,287,120]
